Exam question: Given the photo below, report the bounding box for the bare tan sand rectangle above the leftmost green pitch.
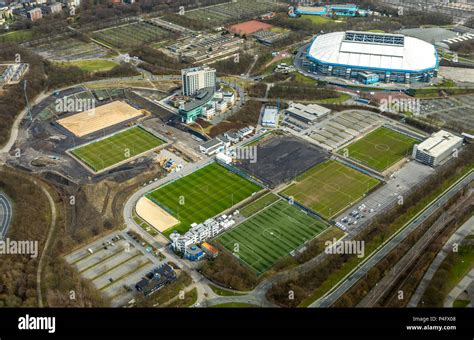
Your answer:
[57,101,143,137]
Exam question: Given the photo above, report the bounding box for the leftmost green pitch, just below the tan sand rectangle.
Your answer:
[72,126,164,171]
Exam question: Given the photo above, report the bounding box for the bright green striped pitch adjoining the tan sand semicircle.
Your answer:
[147,163,261,236]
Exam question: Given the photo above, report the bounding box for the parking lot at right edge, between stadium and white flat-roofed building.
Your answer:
[420,95,474,133]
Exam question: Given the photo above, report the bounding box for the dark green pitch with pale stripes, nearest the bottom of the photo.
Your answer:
[217,200,328,274]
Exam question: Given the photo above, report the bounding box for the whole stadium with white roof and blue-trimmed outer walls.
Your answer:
[306,31,438,84]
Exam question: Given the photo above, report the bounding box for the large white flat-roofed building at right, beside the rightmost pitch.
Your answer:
[412,130,463,167]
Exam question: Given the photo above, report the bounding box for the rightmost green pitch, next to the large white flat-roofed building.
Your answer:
[339,127,418,171]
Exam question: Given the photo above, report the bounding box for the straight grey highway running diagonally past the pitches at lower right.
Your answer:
[309,171,474,307]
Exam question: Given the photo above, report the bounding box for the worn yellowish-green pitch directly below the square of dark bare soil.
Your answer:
[283,160,379,219]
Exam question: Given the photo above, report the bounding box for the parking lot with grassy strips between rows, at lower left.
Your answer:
[65,233,165,306]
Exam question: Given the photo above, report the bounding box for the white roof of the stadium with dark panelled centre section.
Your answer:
[308,31,437,72]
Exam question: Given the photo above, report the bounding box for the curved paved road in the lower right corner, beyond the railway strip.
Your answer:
[408,216,474,307]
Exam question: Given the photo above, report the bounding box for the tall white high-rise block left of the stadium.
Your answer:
[181,66,216,96]
